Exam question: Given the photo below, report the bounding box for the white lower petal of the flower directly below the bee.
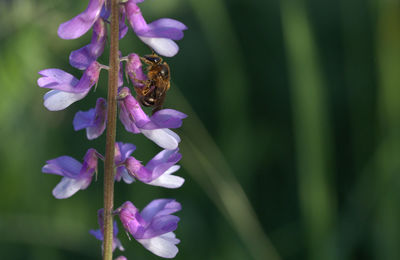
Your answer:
[140,128,181,150]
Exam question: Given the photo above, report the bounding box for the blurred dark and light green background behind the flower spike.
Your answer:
[0,0,400,260]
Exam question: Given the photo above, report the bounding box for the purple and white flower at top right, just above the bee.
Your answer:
[125,0,187,57]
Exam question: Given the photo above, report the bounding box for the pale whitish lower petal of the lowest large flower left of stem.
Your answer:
[53,177,92,199]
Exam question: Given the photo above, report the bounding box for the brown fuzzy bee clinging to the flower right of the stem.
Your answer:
[135,52,171,114]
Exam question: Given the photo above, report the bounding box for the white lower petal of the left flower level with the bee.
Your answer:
[43,90,89,111]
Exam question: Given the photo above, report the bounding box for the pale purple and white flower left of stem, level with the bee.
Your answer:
[37,61,101,111]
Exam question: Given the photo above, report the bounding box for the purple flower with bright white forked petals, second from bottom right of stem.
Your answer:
[125,149,185,189]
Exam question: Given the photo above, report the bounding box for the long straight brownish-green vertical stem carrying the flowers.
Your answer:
[103,0,119,260]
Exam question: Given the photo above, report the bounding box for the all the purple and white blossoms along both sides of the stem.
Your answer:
[37,0,187,260]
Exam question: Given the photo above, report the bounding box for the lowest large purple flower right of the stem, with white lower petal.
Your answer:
[116,199,181,258]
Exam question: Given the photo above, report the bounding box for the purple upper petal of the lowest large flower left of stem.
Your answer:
[42,156,82,178]
